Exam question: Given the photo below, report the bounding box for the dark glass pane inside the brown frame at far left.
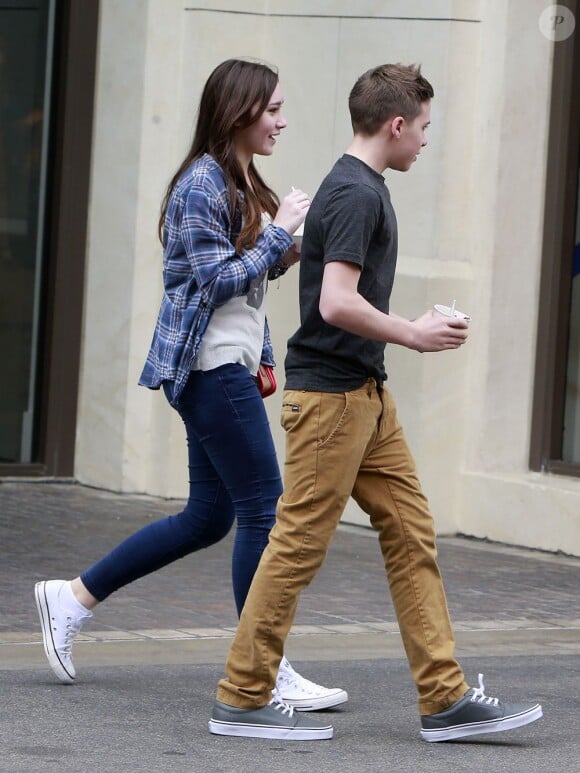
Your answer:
[0,0,54,463]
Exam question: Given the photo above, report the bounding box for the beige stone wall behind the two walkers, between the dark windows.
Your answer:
[77,0,580,554]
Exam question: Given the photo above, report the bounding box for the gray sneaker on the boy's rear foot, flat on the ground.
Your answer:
[209,696,333,741]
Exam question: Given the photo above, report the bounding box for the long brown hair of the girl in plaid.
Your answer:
[158,59,279,252]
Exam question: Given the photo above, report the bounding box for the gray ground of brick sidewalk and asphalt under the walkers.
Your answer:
[0,481,580,773]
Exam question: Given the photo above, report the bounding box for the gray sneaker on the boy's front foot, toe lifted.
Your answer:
[421,674,542,741]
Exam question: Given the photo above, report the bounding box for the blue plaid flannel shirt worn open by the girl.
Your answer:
[139,154,292,404]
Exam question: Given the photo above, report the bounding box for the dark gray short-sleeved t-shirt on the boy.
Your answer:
[285,155,397,392]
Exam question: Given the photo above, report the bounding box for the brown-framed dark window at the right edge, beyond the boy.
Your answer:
[530,18,580,476]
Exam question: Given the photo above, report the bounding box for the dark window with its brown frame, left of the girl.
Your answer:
[0,0,99,476]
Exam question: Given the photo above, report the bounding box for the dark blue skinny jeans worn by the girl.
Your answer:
[81,364,282,615]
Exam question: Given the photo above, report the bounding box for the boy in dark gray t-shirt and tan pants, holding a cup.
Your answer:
[209,65,542,741]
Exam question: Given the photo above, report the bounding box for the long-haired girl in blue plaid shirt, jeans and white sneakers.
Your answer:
[35,59,348,711]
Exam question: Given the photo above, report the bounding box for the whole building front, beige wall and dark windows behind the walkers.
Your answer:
[0,0,580,555]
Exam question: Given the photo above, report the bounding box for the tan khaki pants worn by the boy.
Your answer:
[217,379,469,714]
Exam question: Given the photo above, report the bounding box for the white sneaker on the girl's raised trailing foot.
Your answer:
[34,580,93,684]
